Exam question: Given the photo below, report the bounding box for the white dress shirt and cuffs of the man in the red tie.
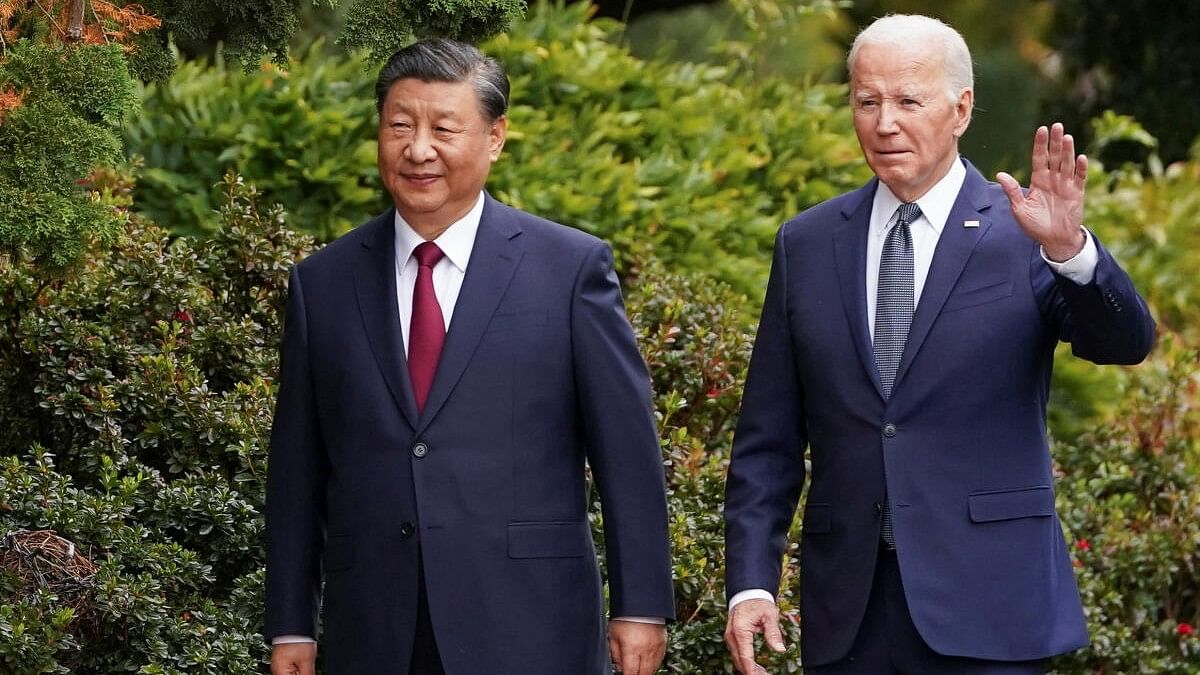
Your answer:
[271,192,666,645]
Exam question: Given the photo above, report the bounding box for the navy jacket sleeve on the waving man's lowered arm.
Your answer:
[725,226,808,597]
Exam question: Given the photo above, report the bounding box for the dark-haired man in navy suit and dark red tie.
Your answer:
[265,40,673,675]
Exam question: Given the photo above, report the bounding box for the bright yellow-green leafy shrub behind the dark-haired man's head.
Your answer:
[126,2,869,297]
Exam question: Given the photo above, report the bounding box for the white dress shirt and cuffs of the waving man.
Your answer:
[730,156,1099,610]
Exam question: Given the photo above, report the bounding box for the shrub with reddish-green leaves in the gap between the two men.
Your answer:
[619,251,799,675]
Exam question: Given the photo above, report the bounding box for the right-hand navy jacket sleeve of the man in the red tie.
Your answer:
[571,244,674,619]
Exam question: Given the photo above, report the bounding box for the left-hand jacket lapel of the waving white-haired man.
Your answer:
[833,179,883,396]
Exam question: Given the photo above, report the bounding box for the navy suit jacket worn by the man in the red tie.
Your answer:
[265,192,673,675]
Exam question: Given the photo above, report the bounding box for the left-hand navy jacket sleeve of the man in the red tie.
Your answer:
[265,268,326,641]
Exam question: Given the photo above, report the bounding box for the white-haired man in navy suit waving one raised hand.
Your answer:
[725,16,1154,675]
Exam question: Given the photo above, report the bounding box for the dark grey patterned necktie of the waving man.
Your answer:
[874,203,920,549]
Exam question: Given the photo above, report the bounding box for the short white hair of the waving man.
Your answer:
[846,14,974,101]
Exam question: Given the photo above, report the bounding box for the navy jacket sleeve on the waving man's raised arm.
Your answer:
[1031,233,1154,365]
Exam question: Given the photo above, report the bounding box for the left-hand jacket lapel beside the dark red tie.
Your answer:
[354,210,418,428]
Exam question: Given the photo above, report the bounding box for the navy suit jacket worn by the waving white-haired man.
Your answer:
[726,163,1154,665]
